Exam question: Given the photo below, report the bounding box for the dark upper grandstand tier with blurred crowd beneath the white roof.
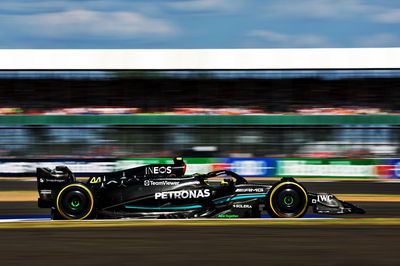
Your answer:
[0,70,400,115]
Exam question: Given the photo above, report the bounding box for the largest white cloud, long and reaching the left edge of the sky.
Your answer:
[0,10,178,39]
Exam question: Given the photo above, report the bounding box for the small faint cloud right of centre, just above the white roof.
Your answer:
[248,30,329,48]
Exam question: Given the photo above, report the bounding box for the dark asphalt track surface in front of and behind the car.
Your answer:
[0,181,400,266]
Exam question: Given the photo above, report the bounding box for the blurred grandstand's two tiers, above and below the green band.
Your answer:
[0,70,400,158]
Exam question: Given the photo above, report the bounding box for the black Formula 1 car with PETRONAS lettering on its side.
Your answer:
[37,157,364,220]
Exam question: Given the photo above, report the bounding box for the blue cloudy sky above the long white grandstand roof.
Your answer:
[0,0,400,49]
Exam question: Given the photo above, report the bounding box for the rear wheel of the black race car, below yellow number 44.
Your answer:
[56,183,94,220]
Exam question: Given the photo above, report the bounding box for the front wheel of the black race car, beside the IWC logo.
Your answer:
[266,181,308,218]
